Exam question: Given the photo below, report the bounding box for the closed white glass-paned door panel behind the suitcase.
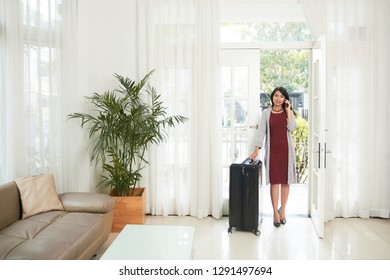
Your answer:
[220,49,260,212]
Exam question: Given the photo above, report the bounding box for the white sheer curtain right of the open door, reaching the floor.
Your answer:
[301,0,390,220]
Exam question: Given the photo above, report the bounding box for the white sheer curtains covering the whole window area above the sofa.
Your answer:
[0,0,77,191]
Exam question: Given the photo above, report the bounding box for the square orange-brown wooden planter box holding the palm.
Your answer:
[111,188,146,232]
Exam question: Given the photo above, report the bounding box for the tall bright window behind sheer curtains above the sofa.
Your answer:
[22,0,61,174]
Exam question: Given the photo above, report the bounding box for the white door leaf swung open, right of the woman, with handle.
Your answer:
[309,37,331,238]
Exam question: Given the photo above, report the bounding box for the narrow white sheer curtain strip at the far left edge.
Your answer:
[0,0,25,183]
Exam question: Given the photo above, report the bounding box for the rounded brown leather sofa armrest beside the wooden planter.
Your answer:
[58,192,115,213]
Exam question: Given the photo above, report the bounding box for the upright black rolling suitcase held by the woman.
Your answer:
[228,158,262,235]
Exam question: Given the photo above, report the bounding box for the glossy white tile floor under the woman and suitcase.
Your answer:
[96,215,390,260]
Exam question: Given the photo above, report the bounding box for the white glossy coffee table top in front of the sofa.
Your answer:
[100,225,195,260]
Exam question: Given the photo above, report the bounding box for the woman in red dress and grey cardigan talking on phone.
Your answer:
[249,87,296,227]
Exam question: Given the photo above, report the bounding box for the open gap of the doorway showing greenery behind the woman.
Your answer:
[260,49,310,217]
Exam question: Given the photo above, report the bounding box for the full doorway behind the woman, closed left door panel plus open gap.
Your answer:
[221,48,310,217]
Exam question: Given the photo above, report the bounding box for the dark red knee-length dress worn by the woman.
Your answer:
[269,112,288,185]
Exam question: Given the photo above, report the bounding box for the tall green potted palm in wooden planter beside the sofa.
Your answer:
[68,71,188,231]
